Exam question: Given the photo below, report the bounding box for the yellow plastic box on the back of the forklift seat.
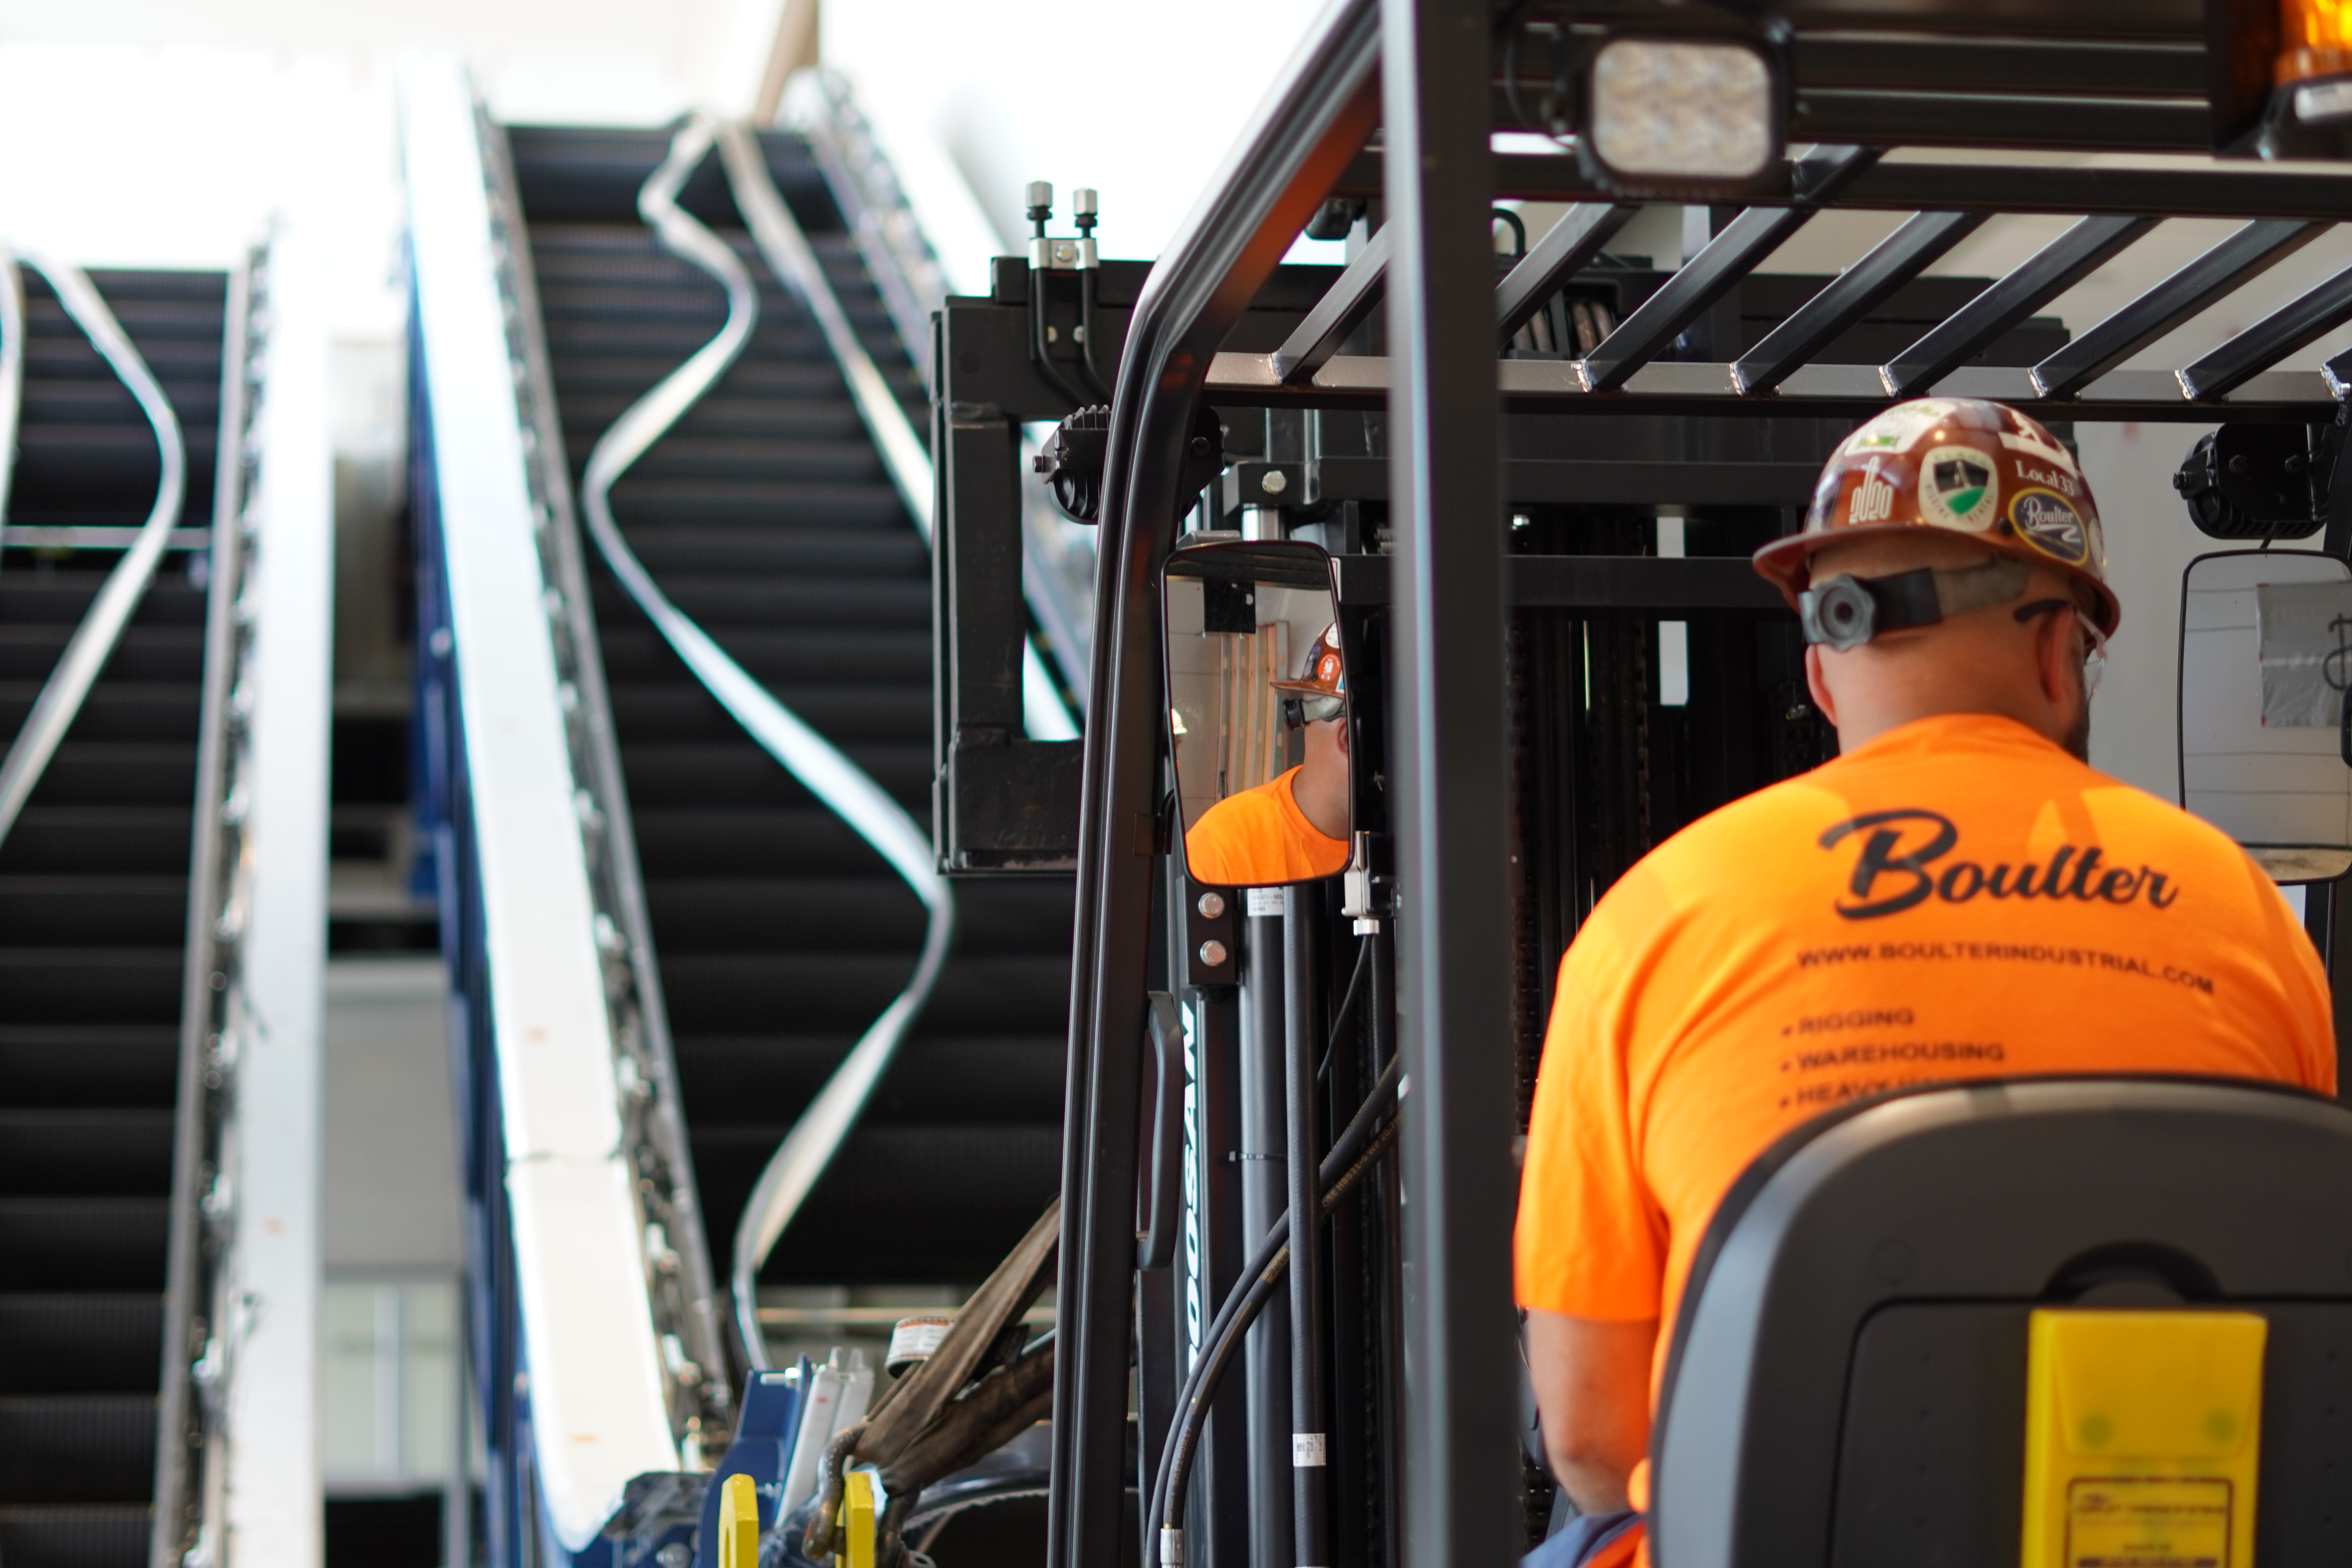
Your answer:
[2023,1307,2270,1568]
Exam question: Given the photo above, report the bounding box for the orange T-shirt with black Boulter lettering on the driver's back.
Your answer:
[1517,715,2336,1396]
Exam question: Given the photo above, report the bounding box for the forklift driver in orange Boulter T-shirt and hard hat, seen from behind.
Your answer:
[1517,399,2336,1568]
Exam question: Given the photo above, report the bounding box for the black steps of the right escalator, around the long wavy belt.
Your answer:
[508,129,1070,1326]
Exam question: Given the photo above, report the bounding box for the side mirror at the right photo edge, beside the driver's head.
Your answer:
[2180,550,2352,882]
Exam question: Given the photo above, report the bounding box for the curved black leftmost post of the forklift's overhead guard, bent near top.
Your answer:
[1047,0,1374,1568]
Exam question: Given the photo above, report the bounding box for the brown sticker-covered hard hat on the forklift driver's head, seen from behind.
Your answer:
[1755,397,2124,637]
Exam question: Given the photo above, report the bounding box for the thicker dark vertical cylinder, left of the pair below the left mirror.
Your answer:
[1240,889,1312,1568]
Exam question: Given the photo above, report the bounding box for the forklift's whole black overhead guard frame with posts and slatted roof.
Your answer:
[1044,0,2352,1568]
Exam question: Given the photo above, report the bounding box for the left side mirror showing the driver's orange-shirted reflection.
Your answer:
[1162,543,1350,886]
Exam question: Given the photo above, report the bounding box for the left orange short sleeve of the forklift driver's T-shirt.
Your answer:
[1515,922,1668,1323]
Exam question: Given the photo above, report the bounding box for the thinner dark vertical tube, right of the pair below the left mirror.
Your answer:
[1282,886,1331,1568]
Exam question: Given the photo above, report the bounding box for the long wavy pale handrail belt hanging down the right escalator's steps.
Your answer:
[581,115,955,1368]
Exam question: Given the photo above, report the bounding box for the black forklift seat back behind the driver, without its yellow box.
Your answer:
[1649,1079,2352,1568]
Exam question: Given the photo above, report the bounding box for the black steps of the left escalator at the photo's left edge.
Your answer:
[0,268,228,1568]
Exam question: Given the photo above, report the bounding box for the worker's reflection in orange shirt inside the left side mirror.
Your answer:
[1183,623,1348,886]
